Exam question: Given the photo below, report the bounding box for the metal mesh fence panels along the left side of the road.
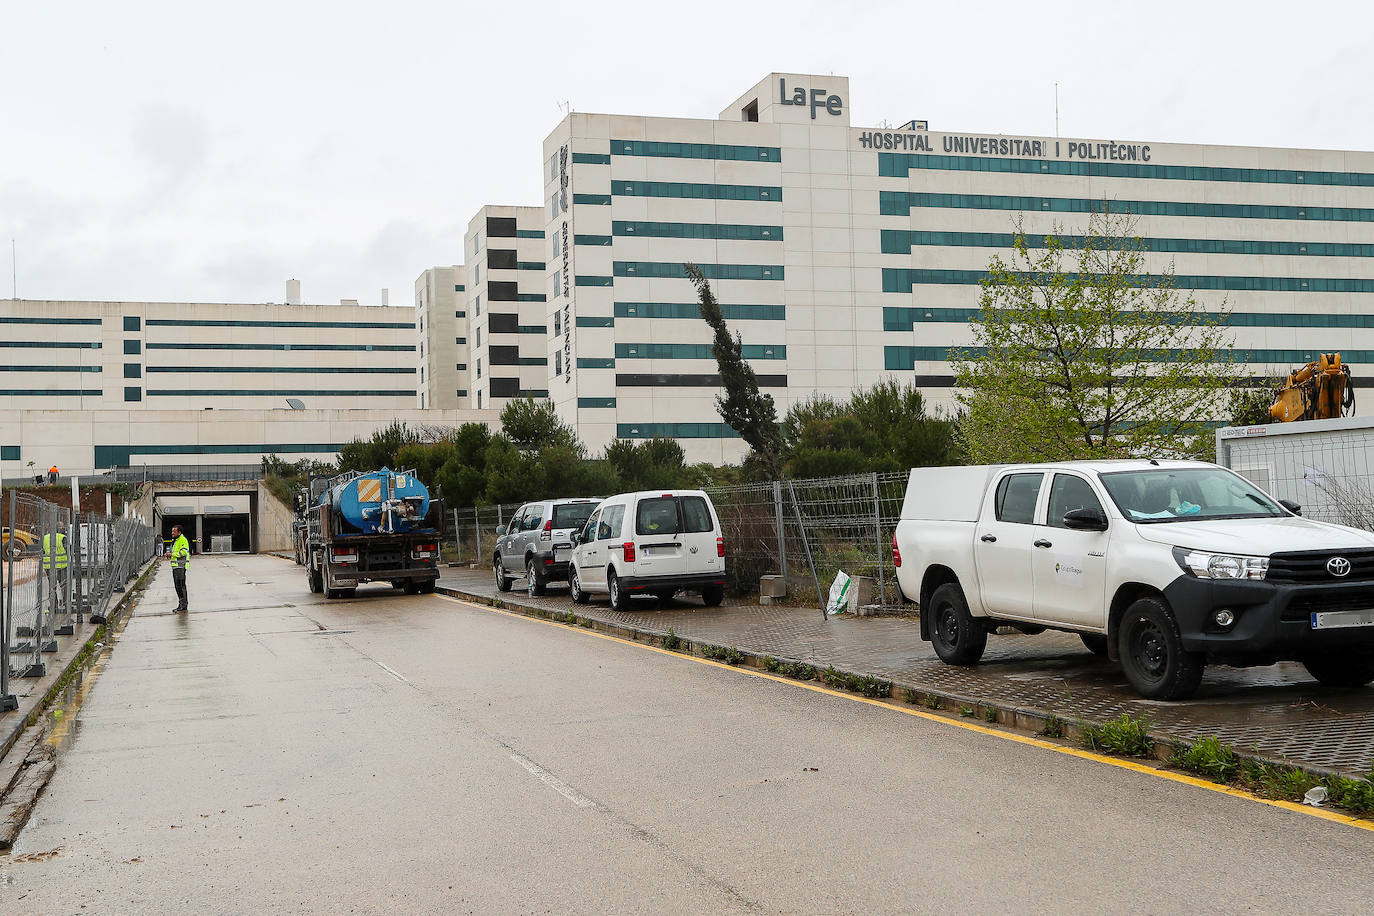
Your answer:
[0,490,155,709]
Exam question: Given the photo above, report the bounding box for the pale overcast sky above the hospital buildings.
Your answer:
[0,0,1374,305]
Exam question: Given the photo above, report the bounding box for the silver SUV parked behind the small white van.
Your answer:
[492,497,600,597]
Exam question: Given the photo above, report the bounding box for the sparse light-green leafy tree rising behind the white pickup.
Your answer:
[951,205,1237,464]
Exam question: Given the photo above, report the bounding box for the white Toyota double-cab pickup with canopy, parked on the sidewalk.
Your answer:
[893,460,1374,699]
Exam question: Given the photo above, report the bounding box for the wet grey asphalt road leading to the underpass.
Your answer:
[8,556,1374,913]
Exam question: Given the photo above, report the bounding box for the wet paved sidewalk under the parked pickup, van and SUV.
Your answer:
[440,567,1374,775]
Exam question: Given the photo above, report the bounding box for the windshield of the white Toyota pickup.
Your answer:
[1102,468,1287,525]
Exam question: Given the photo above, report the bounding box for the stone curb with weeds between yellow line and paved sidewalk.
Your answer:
[434,585,1352,779]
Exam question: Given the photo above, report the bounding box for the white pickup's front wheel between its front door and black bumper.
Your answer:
[1117,597,1206,700]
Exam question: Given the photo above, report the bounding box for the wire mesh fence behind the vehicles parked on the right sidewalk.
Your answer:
[444,471,908,606]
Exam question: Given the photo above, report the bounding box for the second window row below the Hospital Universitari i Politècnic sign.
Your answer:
[878,191,1374,222]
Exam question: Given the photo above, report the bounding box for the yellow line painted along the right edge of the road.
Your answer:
[434,595,1374,832]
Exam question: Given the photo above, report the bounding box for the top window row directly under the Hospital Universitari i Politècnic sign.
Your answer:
[878,152,1374,188]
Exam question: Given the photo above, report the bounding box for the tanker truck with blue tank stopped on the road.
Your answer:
[301,467,444,597]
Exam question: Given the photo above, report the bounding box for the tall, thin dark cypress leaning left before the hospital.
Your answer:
[686,264,782,479]
